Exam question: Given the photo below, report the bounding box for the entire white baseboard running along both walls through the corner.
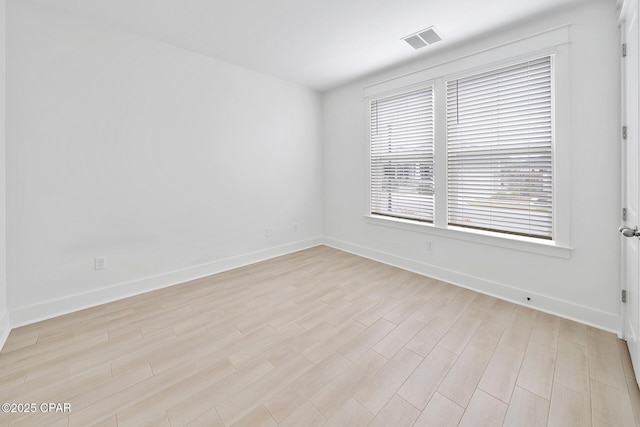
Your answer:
[7,237,622,338]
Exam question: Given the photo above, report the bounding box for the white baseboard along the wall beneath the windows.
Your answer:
[324,237,622,337]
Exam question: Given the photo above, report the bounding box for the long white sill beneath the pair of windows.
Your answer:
[365,215,573,259]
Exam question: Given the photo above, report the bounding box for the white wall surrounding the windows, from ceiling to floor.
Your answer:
[324,0,621,332]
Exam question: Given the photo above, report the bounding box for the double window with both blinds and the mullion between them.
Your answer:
[368,55,555,241]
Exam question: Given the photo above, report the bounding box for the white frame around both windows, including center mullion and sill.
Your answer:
[364,26,572,258]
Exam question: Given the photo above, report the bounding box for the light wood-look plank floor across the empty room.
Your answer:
[0,246,640,427]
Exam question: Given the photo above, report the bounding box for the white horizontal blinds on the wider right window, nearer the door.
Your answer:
[447,57,553,239]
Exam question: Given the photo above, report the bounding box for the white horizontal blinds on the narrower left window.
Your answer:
[370,87,433,221]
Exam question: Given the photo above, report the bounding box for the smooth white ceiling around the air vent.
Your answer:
[28,0,588,90]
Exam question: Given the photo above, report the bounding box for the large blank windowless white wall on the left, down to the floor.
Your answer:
[7,0,322,327]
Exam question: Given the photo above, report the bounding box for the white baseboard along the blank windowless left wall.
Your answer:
[11,237,322,328]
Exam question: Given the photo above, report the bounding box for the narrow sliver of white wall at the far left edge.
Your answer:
[0,0,10,349]
